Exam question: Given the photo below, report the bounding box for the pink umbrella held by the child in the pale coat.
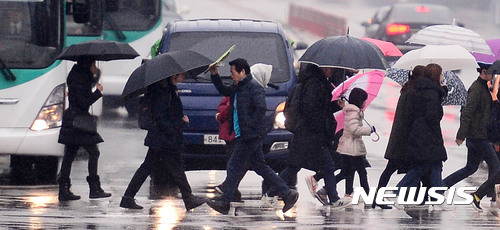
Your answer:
[332,70,385,132]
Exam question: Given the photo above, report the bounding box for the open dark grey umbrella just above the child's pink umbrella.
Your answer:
[299,35,388,70]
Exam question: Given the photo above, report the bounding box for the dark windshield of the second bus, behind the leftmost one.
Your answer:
[104,0,160,31]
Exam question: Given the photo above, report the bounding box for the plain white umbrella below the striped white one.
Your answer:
[392,45,479,71]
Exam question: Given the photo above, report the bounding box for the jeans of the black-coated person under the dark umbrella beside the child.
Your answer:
[280,147,339,202]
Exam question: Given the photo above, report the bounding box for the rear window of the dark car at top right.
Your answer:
[391,6,453,24]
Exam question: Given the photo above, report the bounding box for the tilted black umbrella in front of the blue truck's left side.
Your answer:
[122,50,213,99]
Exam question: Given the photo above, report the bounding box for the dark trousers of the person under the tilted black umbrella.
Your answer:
[124,148,192,198]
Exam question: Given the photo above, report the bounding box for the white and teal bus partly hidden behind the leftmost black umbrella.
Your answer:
[99,0,181,115]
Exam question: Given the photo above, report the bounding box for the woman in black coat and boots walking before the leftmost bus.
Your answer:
[58,57,111,201]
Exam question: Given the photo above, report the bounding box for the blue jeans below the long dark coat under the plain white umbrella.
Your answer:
[396,161,443,192]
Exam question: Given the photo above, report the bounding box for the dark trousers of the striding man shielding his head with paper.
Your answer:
[222,138,290,202]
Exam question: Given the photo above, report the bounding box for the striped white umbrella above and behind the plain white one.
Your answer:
[406,25,493,55]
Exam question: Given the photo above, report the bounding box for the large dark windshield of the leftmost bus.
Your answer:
[0,0,63,69]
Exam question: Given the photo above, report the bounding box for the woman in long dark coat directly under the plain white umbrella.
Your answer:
[398,64,447,190]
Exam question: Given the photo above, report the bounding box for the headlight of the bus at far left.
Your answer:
[30,84,66,131]
